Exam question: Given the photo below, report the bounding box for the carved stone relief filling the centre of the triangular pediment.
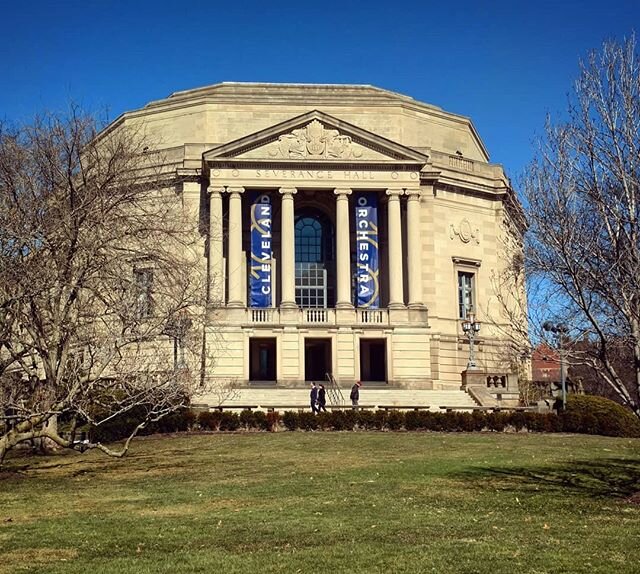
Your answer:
[269,120,363,159]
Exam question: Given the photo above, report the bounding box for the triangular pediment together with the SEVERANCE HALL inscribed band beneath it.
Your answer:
[203,110,429,196]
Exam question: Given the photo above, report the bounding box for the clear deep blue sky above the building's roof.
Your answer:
[0,0,640,177]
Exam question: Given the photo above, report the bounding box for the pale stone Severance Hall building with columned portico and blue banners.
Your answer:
[119,83,521,389]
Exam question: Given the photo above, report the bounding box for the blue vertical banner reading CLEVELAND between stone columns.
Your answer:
[249,194,272,307]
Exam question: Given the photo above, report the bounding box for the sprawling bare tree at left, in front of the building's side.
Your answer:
[0,109,210,463]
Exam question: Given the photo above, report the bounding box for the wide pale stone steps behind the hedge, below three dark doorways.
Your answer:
[193,386,477,412]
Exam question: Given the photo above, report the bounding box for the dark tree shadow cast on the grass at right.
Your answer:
[461,458,640,504]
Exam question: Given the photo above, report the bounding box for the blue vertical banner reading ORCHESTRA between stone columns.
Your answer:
[356,193,380,309]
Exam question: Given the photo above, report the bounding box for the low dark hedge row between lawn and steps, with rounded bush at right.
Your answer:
[93,396,640,442]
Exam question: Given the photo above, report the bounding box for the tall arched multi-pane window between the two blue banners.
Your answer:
[295,209,334,307]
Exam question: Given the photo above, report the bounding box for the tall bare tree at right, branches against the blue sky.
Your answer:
[522,36,640,416]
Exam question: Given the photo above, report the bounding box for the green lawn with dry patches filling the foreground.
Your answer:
[0,432,640,574]
